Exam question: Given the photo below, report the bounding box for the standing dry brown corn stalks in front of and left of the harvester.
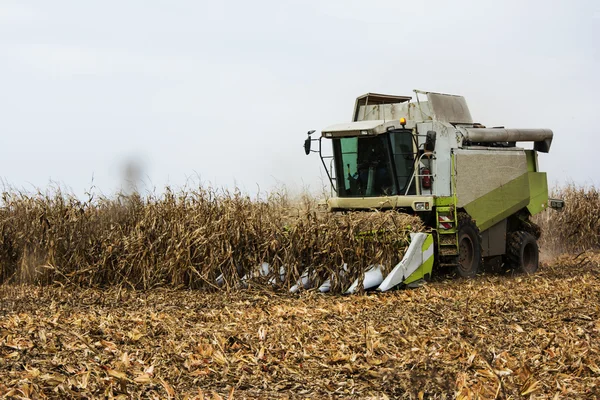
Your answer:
[0,188,422,291]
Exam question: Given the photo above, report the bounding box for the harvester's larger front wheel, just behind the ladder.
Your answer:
[456,213,481,278]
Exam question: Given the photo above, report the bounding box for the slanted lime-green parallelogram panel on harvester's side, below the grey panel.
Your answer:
[465,173,530,232]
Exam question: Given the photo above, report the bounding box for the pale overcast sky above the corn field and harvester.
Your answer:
[0,0,600,198]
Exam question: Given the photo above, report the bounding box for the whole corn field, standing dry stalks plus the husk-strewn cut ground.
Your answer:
[0,186,600,400]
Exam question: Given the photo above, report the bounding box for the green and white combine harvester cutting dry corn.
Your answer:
[304,90,563,292]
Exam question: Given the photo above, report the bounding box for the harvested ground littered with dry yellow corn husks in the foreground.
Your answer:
[0,254,600,399]
